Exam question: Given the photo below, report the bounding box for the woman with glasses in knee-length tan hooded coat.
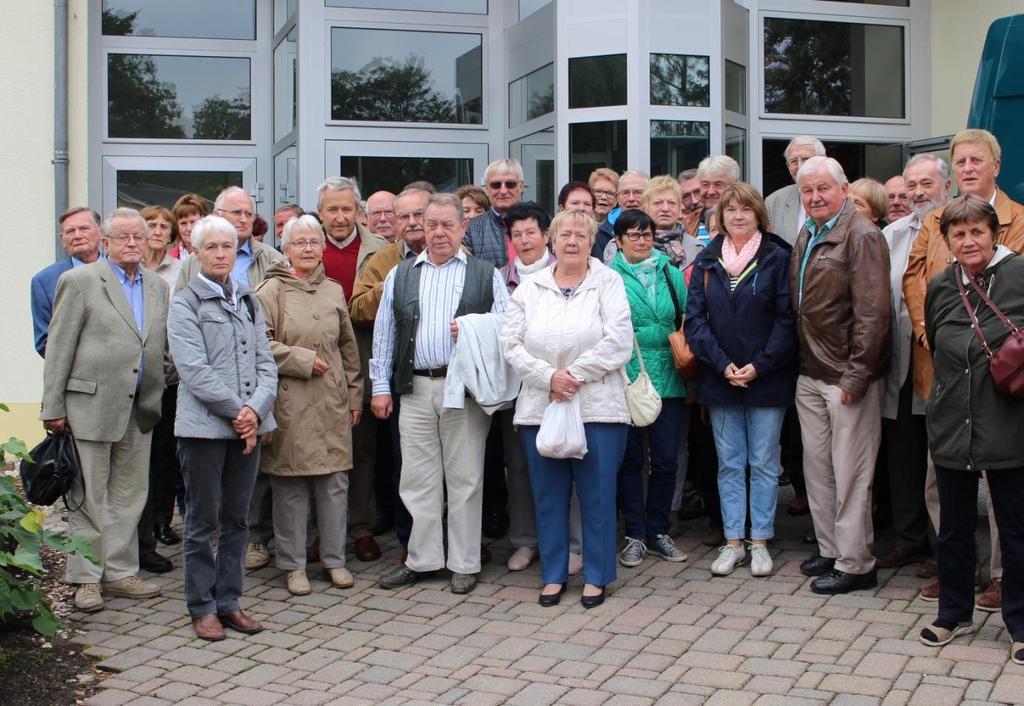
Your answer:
[256,215,362,595]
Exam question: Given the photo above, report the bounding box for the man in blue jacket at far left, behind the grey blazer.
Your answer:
[29,206,99,358]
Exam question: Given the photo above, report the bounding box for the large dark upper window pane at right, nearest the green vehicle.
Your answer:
[765,17,905,118]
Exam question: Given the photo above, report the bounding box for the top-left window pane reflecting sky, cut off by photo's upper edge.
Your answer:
[102,0,256,39]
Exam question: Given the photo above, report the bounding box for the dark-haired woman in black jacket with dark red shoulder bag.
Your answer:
[921,196,1024,664]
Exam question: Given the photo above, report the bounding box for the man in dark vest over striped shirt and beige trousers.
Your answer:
[370,194,508,593]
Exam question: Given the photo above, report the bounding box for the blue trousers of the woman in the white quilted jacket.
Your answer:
[519,423,622,586]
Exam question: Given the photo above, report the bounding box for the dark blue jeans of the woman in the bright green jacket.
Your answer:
[618,398,685,541]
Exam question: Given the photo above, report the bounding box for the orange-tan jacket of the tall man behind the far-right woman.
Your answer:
[903,191,1024,399]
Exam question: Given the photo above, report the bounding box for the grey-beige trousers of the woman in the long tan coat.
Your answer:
[270,470,348,571]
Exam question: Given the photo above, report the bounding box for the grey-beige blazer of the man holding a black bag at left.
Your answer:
[39,259,168,442]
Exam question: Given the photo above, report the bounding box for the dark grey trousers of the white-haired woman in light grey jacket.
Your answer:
[178,439,260,618]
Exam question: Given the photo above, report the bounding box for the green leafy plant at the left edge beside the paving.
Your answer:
[0,404,96,635]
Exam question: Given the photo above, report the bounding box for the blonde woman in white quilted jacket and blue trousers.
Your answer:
[502,210,633,608]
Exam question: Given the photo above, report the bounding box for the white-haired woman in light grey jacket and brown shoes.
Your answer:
[167,216,278,640]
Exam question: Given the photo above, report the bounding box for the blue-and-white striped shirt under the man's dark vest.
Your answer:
[370,250,509,394]
